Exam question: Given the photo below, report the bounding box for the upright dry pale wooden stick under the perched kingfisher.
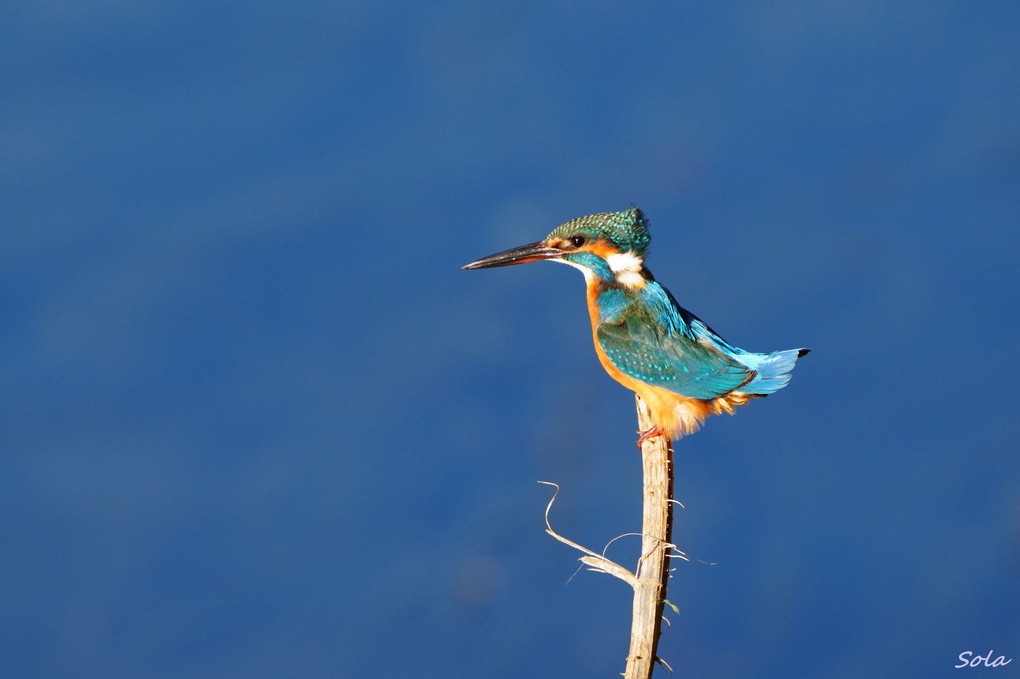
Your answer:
[623,396,673,679]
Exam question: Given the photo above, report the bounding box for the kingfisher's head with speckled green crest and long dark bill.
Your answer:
[463,201,652,288]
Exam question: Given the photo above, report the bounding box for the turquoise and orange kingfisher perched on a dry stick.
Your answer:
[462,206,810,438]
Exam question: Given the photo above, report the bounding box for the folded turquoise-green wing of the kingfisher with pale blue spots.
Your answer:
[596,281,756,400]
